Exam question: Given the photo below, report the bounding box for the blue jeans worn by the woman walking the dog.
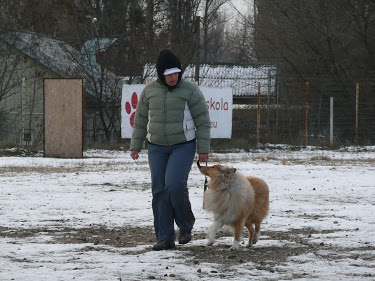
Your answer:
[148,140,196,241]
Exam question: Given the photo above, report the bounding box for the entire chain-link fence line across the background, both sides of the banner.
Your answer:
[0,77,375,150]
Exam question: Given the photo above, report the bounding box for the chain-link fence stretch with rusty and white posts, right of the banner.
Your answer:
[225,80,375,148]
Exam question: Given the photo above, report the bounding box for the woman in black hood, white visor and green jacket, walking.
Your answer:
[130,49,210,251]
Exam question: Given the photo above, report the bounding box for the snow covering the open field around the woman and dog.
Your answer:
[0,146,375,281]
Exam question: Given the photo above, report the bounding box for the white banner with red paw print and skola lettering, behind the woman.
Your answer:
[121,84,233,139]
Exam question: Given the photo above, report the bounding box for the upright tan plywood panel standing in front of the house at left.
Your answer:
[44,79,84,158]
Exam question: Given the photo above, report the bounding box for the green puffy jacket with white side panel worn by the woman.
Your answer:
[130,79,211,153]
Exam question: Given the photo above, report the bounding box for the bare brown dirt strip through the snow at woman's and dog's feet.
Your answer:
[0,226,375,278]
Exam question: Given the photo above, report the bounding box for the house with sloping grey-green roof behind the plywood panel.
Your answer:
[0,32,122,144]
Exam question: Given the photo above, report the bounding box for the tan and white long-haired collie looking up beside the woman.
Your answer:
[197,161,269,250]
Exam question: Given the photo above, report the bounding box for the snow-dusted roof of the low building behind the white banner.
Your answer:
[144,63,280,100]
